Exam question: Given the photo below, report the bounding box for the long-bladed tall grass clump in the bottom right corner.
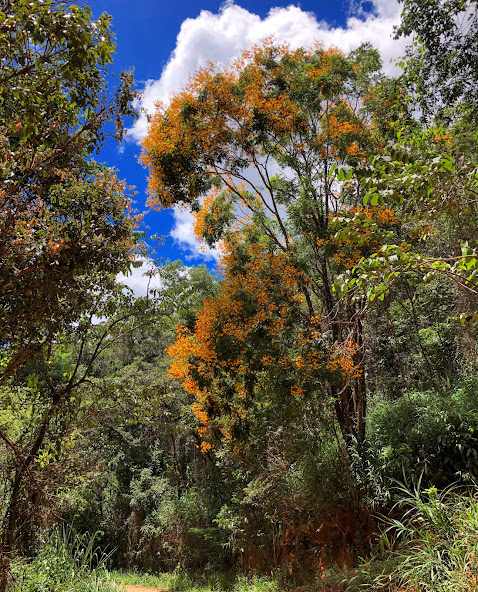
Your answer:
[342,482,478,592]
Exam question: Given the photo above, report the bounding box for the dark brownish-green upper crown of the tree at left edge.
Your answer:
[0,0,135,383]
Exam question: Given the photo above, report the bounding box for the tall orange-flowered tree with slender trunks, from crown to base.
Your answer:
[143,42,393,446]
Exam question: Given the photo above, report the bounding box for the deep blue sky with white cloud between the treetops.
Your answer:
[89,0,404,290]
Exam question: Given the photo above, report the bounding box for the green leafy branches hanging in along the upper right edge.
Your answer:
[326,0,478,366]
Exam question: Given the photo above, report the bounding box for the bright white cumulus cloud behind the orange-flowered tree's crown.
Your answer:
[133,0,405,257]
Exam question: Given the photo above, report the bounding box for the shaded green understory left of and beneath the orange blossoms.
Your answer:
[56,263,355,577]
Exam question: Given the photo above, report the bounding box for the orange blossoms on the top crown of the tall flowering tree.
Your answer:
[142,39,373,214]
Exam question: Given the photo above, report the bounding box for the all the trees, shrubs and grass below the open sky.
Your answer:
[0,0,478,592]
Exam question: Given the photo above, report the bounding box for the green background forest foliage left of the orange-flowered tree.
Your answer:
[56,262,232,570]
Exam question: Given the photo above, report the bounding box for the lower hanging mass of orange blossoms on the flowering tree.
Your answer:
[168,238,318,450]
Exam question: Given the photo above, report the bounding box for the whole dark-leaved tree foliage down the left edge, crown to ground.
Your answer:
[0,0,137,568]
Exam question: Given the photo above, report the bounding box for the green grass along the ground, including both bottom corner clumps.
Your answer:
[9,480,478,592]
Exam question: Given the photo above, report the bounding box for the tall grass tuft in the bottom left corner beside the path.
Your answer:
[8,524,117,592]
